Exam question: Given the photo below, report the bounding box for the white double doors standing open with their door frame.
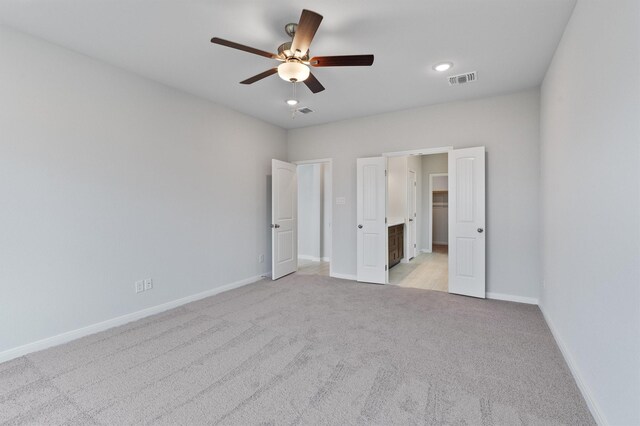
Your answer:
[356,146,486,298]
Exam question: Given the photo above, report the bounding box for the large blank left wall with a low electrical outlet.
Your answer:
[0,27,287,352]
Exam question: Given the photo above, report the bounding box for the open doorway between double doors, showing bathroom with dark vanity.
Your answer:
[387,153,449,292]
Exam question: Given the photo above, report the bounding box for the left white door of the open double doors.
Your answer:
[356,157,389,284]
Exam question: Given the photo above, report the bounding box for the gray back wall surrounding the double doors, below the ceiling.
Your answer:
[288,90,540,298]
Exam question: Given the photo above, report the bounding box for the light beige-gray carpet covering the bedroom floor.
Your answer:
[0,274,593,425]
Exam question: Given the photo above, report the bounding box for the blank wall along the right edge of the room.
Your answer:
[541,0,640,425]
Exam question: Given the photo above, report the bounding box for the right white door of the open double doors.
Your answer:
[449,146,486,298]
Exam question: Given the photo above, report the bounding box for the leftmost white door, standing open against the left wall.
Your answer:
[271,160,298,280]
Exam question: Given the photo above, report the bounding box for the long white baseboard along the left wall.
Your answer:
[0,272,270,363]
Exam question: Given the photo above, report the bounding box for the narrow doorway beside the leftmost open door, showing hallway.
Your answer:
[296,160,332,276]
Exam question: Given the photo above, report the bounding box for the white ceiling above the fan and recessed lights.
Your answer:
[0,0,575,128]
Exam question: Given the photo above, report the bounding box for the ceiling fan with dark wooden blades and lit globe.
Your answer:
[211,9,373,93]
